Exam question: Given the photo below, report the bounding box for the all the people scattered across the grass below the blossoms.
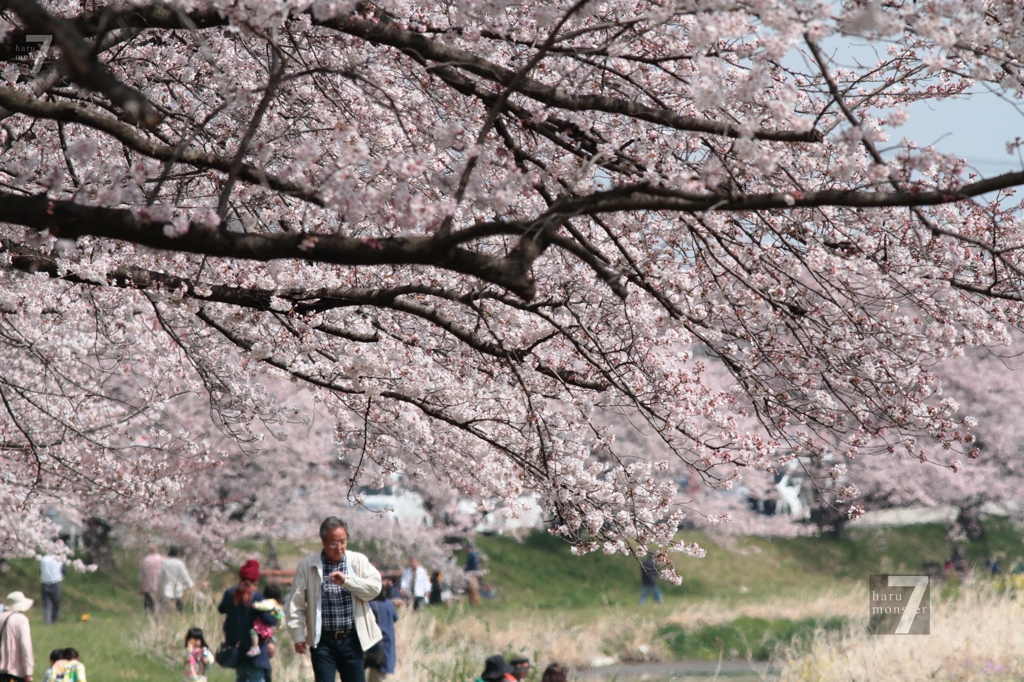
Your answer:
[0,516,662,682]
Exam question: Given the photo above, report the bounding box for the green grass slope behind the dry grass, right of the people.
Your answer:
[460,518,1024,610]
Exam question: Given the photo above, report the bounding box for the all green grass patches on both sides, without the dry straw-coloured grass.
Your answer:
[0,519,1024,682]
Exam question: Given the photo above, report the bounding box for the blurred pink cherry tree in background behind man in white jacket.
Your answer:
[47,375,466,570]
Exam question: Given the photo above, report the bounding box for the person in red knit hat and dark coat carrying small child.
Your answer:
[217,559,278,682]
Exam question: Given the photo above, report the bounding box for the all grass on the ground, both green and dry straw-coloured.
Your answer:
[8,520,1024,682]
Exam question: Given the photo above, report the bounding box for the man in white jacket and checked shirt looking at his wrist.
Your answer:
[285,516,381,682]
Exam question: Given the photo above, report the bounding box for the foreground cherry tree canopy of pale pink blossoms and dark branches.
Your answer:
[0,0,1024,579]
